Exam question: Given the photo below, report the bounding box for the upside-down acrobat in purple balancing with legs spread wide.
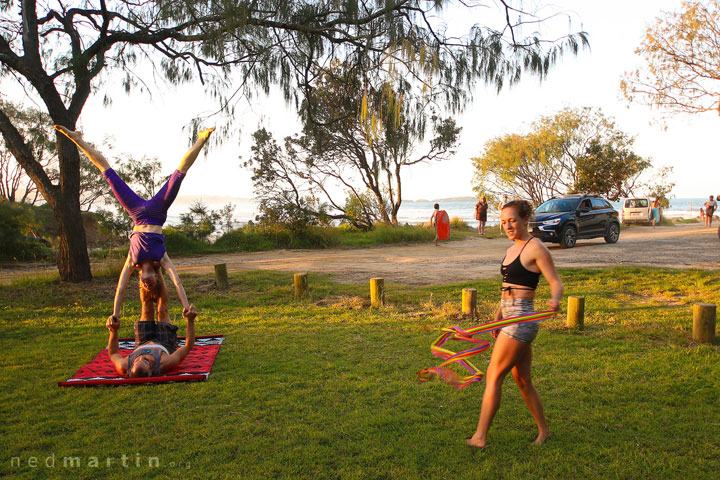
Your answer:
[55,125,215,318]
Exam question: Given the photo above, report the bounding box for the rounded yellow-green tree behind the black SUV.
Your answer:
[473,108,651,205]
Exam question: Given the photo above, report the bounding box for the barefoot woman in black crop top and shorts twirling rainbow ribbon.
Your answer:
[466,200,563,448]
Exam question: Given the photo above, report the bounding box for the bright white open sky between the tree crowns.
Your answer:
[40,0,720,203]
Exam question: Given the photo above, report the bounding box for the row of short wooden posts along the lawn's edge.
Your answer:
[215,263,716,344]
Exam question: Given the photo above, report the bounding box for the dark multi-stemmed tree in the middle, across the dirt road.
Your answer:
[247,65,460,229]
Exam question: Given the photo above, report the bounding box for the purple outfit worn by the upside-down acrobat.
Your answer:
[103,168,185,264]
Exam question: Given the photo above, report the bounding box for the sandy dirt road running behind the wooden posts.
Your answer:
[0,224,720,285]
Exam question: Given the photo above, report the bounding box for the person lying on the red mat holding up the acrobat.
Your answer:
[106,273,197,377]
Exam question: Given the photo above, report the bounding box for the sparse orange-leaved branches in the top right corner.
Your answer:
[620,0,720,117]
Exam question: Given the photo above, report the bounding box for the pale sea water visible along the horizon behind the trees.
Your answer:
[166,198,707,227]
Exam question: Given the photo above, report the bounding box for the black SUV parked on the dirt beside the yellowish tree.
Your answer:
[530,195,620,248]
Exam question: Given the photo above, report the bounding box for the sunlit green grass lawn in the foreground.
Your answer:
[0,268,720,479]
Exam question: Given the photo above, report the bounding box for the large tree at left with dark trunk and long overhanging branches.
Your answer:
[0,0,587,281]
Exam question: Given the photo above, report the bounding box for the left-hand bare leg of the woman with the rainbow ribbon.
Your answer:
[466,334,530,448]
